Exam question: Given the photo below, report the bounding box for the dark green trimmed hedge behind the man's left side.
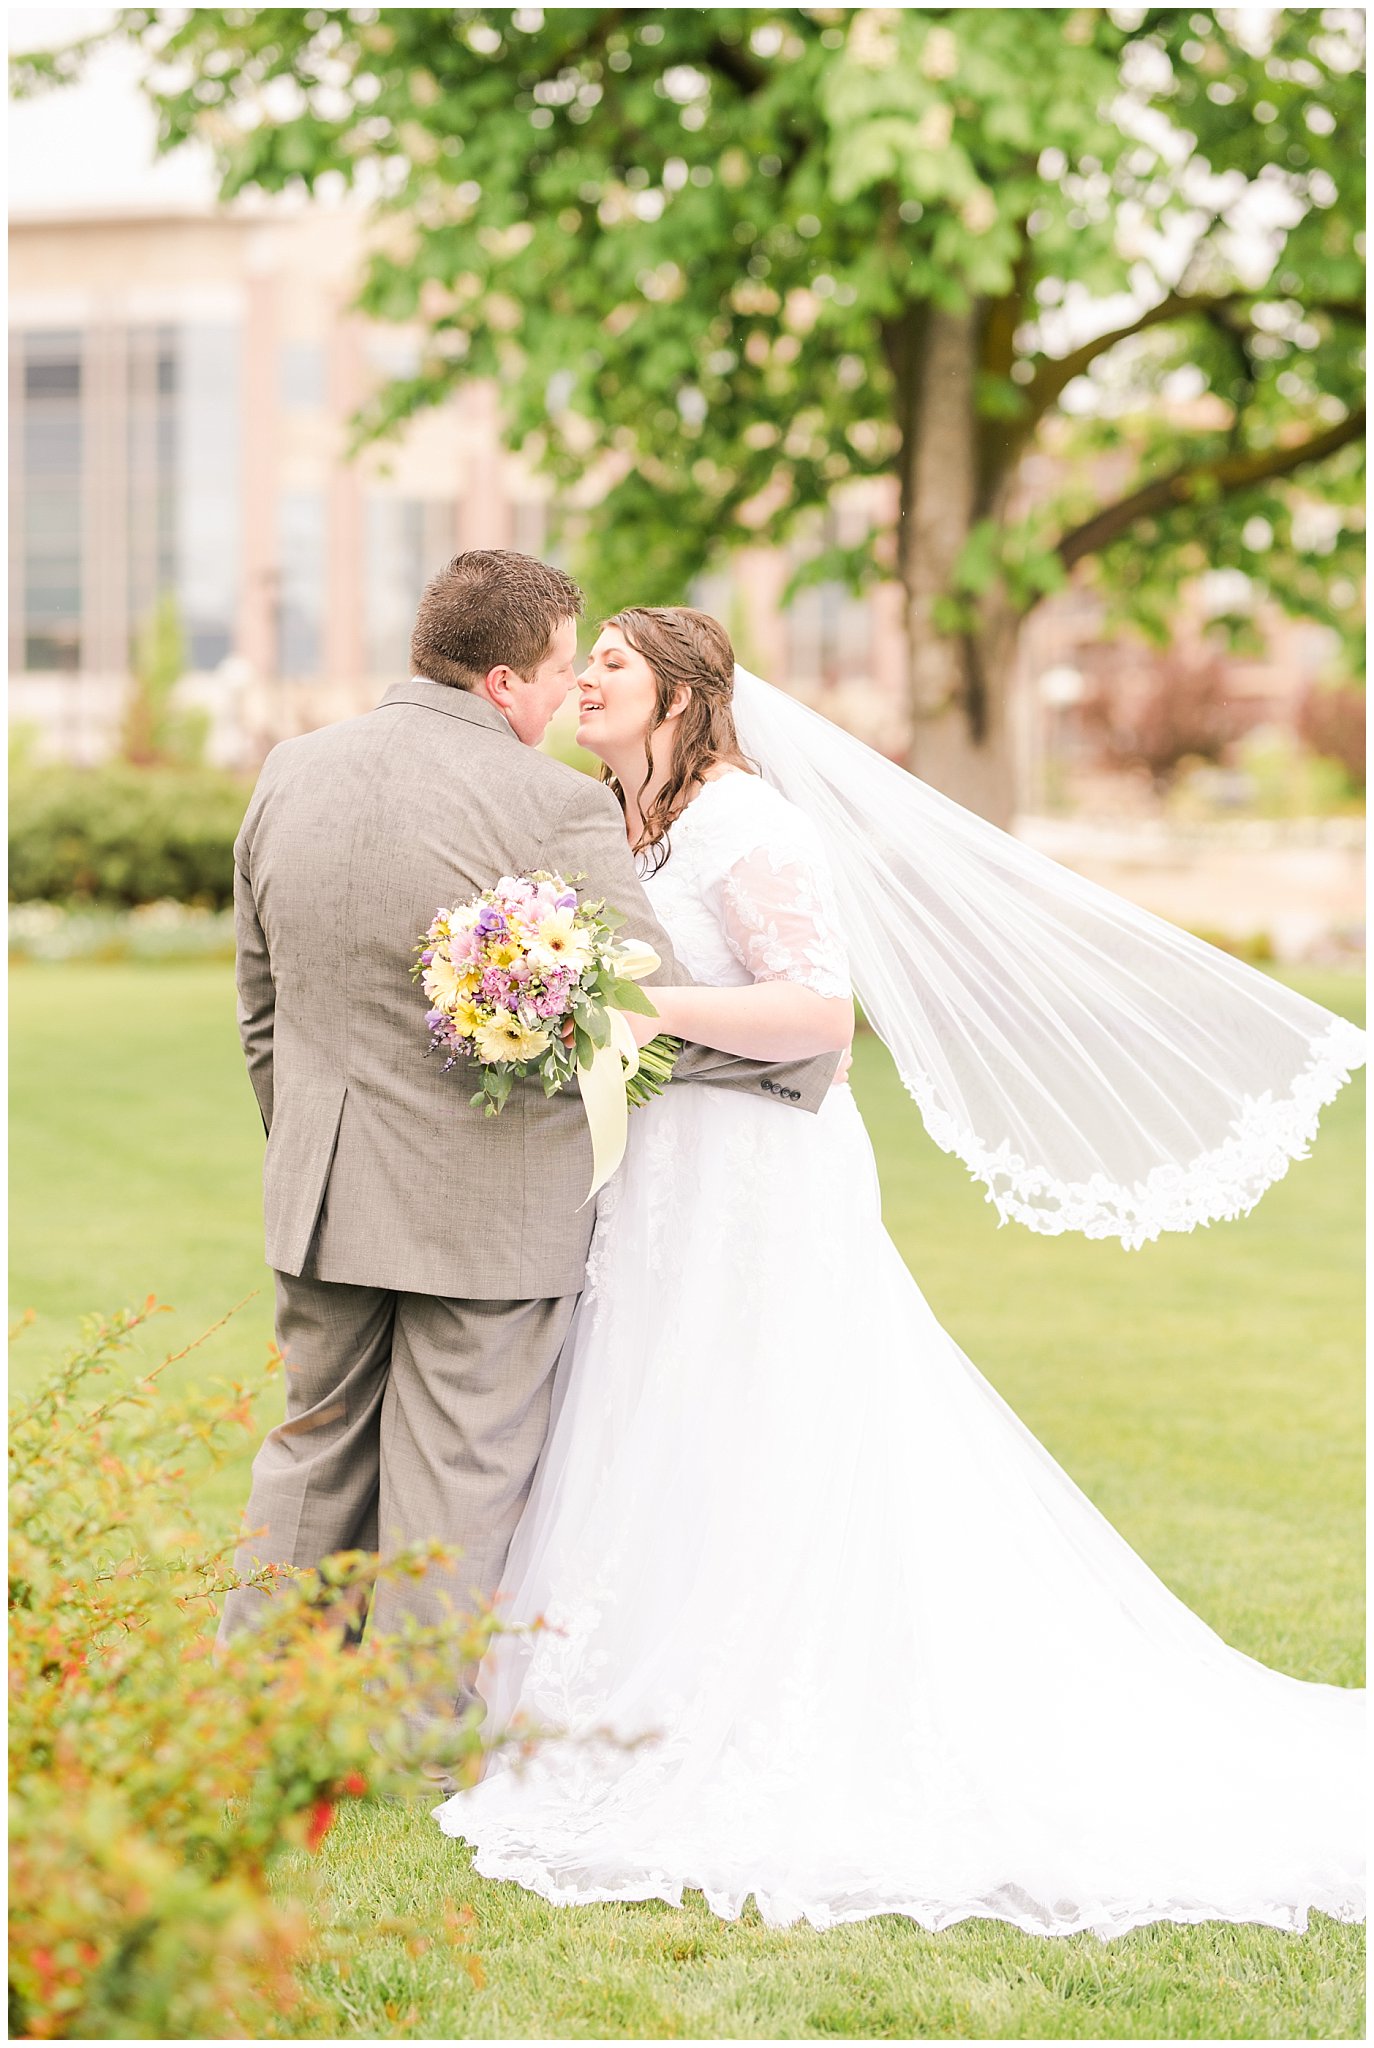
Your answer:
[10,762,250,909]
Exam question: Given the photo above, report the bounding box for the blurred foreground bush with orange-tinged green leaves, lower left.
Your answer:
[10,1298,524,2040]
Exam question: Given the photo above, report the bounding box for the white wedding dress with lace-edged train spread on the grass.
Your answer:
[438,772,1364,1937]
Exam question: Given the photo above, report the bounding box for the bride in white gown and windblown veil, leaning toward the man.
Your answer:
[436,608,1364,1937]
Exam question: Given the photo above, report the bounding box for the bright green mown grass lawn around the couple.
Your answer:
[10,967,1364,2040]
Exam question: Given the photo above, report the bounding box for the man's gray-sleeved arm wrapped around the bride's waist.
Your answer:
[541,776,840,1110]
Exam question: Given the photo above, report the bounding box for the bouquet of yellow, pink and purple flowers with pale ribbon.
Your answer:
[412,874,682,1192]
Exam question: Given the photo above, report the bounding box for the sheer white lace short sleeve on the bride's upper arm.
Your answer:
[719,805,850,995]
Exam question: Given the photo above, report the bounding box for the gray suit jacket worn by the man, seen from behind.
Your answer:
[233,680,835,1300]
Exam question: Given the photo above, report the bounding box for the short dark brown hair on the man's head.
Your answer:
[410,547,584,690]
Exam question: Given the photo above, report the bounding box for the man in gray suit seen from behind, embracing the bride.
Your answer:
[219,551,835,1710]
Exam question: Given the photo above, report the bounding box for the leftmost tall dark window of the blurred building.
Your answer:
[18,330,84,670]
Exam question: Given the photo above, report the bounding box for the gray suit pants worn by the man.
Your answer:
[219,1272,577,1706]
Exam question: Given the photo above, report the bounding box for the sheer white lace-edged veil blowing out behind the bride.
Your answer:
[735,668,1364,1247]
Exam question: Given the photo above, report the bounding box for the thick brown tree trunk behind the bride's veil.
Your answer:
[889,303,1016,825]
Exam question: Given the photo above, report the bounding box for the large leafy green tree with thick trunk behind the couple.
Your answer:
[20,8,1364,817]
